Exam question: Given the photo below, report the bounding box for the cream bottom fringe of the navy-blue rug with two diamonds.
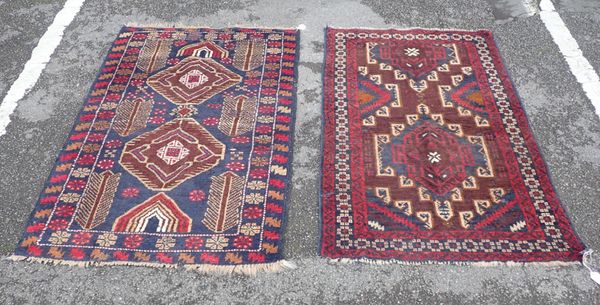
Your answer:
[6,255,297,276]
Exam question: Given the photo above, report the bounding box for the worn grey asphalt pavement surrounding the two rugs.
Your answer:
[0,0,600,305]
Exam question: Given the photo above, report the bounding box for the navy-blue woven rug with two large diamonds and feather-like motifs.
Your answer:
[13,27,298,273]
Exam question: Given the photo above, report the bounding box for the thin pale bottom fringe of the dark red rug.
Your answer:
[329,257,581,267]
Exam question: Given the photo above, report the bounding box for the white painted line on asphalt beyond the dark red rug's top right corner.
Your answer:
[540,0,600,116]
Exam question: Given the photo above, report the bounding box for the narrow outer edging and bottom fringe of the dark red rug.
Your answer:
[317,26,587,267]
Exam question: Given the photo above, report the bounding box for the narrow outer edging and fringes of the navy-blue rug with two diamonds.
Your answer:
[4,23,301,276]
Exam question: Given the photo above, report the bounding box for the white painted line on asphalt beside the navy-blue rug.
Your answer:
[0,0,85,137]
